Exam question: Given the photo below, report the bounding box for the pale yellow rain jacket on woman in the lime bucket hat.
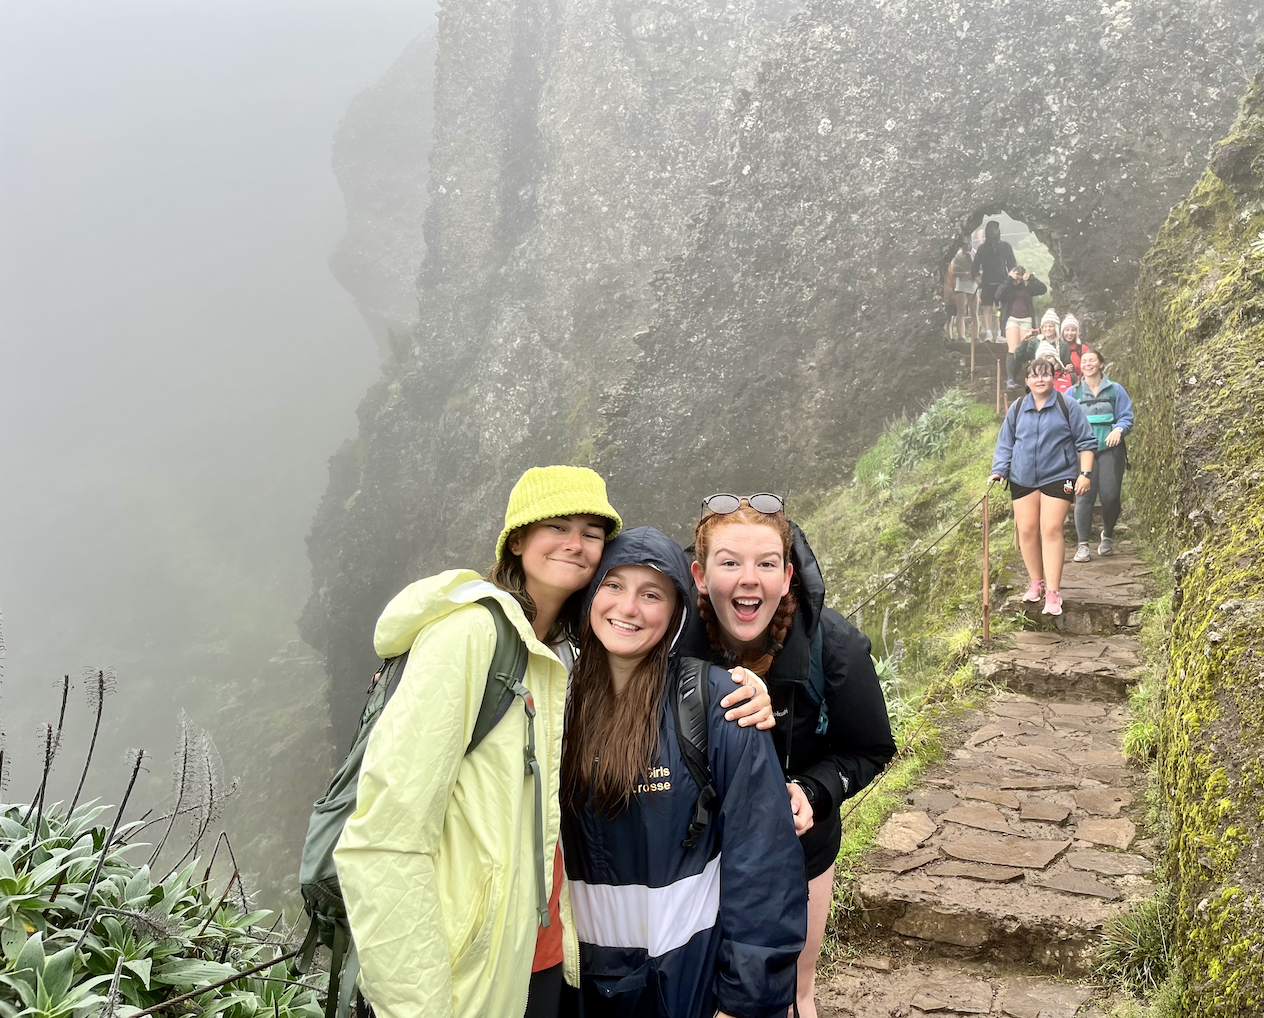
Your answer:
[334,569,579,1018]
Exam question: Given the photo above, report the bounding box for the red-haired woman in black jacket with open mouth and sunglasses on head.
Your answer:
[681,493,895,1018]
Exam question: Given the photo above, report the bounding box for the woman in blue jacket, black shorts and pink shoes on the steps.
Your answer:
[991,359,1097,615]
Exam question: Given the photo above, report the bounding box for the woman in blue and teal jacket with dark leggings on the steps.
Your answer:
[1071,346,1133,561]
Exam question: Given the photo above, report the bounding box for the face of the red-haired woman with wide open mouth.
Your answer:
[693,522,793,650]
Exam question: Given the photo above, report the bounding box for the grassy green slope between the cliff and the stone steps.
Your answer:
[801,392,1019,957]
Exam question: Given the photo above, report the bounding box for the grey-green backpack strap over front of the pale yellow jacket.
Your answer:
[465,597,549,927]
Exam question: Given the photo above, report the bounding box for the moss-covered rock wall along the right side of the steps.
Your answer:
[1122,61,1264,1018]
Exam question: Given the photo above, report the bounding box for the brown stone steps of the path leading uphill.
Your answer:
[818,528,1154,1018]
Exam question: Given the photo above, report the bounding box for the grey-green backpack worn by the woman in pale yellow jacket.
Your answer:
[295,597,549,1018]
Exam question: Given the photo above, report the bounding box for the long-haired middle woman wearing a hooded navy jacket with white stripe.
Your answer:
[561,527,808,1018]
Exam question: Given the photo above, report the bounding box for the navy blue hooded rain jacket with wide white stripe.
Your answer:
[561,527,808,1018]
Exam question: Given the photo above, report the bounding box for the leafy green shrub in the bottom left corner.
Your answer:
[0,806,325,1018]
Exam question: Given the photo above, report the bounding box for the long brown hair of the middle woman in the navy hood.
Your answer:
[561,592,685,817]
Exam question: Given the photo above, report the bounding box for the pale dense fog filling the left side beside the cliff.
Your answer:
[0,0,435,905]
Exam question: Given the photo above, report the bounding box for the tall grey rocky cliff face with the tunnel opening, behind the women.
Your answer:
[303,0,1260,726]
